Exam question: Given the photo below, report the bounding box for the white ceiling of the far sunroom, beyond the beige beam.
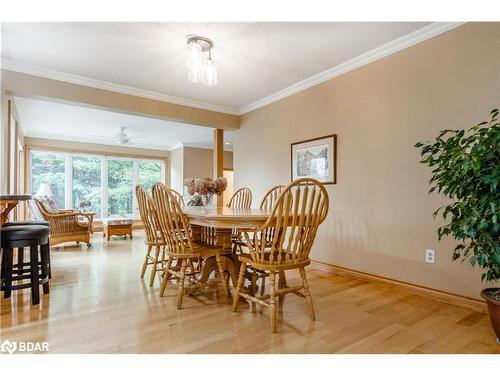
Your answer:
[14,97,233,150]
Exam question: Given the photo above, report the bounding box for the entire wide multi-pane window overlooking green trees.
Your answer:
[31,151,165,218]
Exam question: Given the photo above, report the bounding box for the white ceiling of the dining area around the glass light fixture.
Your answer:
[1,22,429,113]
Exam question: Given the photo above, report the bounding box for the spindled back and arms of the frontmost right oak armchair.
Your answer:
[244,178,329,265]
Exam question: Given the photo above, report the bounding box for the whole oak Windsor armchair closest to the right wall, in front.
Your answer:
[233,178,329,333]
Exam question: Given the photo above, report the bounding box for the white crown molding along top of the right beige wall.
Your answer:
[239,22,464,115]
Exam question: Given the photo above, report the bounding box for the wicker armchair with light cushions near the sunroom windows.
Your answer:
[29,197,94,247]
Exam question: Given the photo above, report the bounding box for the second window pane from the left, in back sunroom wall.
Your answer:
[71,156,102,218]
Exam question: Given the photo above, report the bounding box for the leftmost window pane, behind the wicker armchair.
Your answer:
[31,152,65,207]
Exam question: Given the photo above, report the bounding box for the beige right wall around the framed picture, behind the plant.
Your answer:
[234,23,500,298]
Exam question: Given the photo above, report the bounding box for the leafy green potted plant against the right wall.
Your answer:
[415,109,500,344]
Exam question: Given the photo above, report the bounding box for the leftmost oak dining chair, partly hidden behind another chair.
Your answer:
[135,185,166,287]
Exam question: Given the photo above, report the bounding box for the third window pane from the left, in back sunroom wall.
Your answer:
[108,159,134,216]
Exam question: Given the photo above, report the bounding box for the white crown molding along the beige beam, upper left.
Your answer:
[0,59,240,115]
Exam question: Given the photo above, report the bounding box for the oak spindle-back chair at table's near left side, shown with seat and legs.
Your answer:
[153,184,229,310]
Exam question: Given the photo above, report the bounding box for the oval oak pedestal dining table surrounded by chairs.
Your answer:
[183,206,271,287]
